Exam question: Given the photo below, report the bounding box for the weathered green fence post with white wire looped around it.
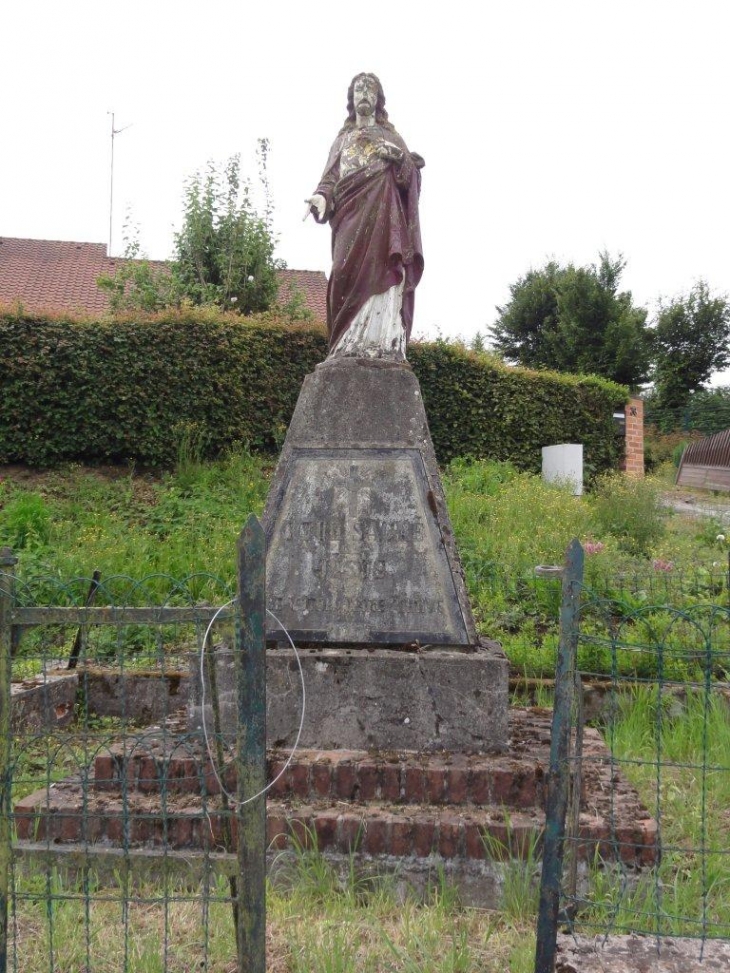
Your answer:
[234,515,266,973]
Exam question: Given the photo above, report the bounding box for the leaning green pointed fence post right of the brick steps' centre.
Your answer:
[535,540,583,973]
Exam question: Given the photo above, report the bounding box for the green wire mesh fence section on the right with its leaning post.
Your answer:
[535,541,730,973]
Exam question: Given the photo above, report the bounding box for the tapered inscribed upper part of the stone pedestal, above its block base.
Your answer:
[263,359,477,647]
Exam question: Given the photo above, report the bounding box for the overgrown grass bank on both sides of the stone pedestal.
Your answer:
[0,456,730,675]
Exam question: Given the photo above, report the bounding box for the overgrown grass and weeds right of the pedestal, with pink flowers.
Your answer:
[444,461,730,676]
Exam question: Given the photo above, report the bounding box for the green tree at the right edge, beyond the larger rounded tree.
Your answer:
[653,280,730,409]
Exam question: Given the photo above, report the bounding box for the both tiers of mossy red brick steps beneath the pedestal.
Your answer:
[15,710,656,865]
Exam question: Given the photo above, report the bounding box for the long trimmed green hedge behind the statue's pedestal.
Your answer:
[0,309,627,471]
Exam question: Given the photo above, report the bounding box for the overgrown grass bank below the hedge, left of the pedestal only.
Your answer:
[0,452,271,579]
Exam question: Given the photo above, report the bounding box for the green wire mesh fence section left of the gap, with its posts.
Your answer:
[0,517,266,973]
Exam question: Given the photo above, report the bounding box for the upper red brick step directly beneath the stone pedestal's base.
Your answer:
[94,738,545,810]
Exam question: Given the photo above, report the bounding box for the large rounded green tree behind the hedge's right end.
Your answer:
[491,253,651,388]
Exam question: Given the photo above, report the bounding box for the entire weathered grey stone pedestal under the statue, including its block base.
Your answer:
[190,359,508,753]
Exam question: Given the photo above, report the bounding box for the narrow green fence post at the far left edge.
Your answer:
[0,547,18,973]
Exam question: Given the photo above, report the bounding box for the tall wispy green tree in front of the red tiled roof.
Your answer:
[99,139,284,314]
